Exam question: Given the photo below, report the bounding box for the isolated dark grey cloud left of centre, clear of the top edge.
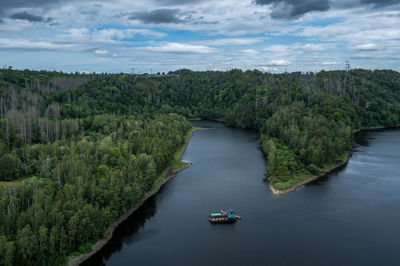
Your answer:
[128,8,188,24]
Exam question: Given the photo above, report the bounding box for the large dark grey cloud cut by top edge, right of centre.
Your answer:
[256,0,330,19]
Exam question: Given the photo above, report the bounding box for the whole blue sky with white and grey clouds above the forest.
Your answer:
[0,0,400,73]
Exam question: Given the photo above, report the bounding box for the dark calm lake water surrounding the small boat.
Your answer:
[83,121,400,265]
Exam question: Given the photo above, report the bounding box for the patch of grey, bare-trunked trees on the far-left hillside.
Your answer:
[0,69,94,147]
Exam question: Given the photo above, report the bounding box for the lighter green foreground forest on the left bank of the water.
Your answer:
[0,114,191,265]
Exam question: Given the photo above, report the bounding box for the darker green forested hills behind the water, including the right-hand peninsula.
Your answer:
[43,69,400,189]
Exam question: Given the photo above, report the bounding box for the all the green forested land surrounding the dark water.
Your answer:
[0,68,400,265]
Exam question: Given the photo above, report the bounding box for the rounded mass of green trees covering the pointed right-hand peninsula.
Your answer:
[261,102,352,187]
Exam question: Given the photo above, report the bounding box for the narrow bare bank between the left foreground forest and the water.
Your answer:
[67,127,202,266]
